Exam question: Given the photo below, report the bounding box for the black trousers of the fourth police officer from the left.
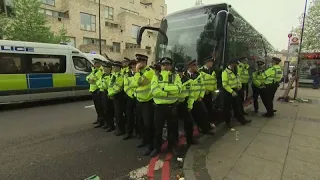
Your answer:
[125,95,136,135]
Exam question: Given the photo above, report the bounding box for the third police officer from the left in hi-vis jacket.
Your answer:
[108,61,125,136]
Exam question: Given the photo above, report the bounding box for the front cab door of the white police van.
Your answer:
[72,55,92,96]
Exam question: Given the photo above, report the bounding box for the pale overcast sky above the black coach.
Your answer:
[165,0,305,50]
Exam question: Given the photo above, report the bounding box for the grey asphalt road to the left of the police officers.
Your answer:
[0,101,150,180]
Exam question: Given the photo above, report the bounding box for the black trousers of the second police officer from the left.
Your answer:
[101,92,114,128]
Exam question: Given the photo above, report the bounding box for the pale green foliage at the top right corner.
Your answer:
[292,1,320,52]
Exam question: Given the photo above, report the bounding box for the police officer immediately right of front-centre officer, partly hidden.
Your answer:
[175,64,198,146]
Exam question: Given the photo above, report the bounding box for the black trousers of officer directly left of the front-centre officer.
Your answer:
[138,100,154,150]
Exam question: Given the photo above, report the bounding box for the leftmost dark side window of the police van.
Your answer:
[0,53,26,74]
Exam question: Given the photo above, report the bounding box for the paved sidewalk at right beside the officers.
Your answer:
[183,88,320,180]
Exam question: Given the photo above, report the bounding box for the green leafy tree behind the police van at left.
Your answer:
[3,0,67,43]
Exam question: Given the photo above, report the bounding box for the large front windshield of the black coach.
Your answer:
[156,5,226,63]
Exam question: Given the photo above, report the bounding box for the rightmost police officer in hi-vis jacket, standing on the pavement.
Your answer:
[262,57,282,117]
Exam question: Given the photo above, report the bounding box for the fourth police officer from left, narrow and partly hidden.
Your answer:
[123,60,136,140]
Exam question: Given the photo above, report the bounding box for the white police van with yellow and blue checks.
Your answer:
[0,40,106,104]
